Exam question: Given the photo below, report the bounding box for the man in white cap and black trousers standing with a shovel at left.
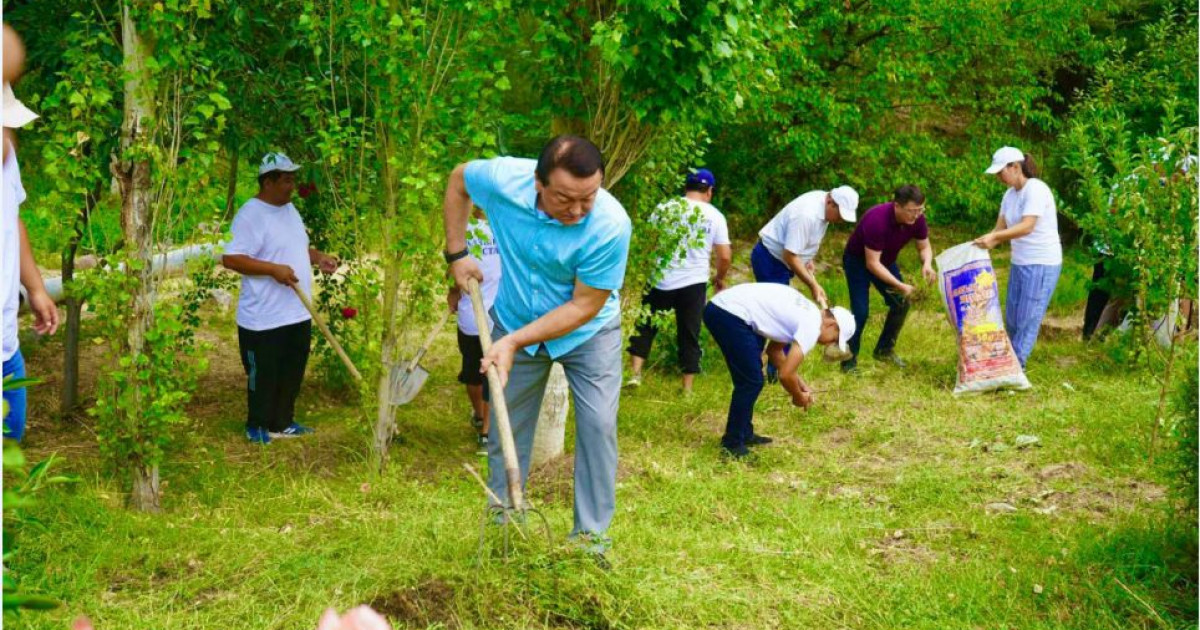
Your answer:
[221,154,337,444]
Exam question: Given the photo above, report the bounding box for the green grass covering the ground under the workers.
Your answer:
[5,234,1196,630]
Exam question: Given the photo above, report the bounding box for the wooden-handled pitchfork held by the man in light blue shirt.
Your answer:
[463,278,552,558]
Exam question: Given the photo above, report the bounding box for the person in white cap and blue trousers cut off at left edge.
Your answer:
[0,83,59,442]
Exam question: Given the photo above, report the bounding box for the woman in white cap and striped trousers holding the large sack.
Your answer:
[974,146,1062,368]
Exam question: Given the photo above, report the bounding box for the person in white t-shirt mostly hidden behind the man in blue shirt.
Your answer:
[446,206,500,455]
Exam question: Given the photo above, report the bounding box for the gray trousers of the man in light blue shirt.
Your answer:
[487,317,622,536]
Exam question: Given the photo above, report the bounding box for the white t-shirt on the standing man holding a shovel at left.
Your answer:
[224,197,312,330]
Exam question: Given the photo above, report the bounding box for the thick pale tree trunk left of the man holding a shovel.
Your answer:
[118,2,158,511]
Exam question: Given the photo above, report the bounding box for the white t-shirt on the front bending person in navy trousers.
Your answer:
[713,282,821,354]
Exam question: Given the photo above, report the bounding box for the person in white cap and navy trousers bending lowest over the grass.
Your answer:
[704,282,854,458]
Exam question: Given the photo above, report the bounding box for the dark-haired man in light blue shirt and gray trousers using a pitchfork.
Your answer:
[444,136,631,553]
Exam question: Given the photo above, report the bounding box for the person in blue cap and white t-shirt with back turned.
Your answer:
[625,168,733,394]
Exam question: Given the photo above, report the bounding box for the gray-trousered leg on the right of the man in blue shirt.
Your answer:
[559,317,620,537]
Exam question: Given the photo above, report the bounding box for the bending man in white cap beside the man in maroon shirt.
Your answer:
[750,186,858,305]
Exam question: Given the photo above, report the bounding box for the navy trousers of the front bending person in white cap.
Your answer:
[704,302,770,449]
